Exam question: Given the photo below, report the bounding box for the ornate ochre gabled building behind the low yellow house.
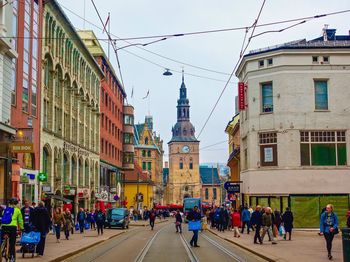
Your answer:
[134,116,164,204]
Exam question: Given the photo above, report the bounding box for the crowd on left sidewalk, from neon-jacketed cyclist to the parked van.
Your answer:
[0,198,106,258]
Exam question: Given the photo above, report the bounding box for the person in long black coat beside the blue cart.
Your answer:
[33,201,51,256]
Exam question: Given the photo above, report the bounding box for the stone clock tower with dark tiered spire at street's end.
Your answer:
[166,71,201,204]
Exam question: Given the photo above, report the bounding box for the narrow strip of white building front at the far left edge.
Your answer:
[0,1,19,203]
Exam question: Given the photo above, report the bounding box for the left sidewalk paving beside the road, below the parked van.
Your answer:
[16,229,125,261]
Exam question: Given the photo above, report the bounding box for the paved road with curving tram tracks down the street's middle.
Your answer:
[66,222,264,262]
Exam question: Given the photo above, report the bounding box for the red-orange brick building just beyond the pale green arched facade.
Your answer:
[78,31,127,206]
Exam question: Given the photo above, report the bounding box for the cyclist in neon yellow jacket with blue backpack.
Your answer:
[1,198,24,261]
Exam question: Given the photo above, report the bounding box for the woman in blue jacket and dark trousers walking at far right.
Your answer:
[320,204,339,260]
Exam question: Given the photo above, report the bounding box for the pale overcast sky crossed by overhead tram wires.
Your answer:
[59,0,350,163]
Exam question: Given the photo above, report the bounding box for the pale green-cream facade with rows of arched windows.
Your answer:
[41,1,104,211]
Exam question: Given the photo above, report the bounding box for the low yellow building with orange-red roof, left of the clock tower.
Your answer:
[124,162,154,210]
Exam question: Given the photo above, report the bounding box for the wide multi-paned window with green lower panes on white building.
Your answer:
[300,131,347,166]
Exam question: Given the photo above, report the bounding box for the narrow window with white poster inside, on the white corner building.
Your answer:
[259,132,278,166]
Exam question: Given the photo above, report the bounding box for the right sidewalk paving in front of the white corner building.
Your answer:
[209,229,343,262]
